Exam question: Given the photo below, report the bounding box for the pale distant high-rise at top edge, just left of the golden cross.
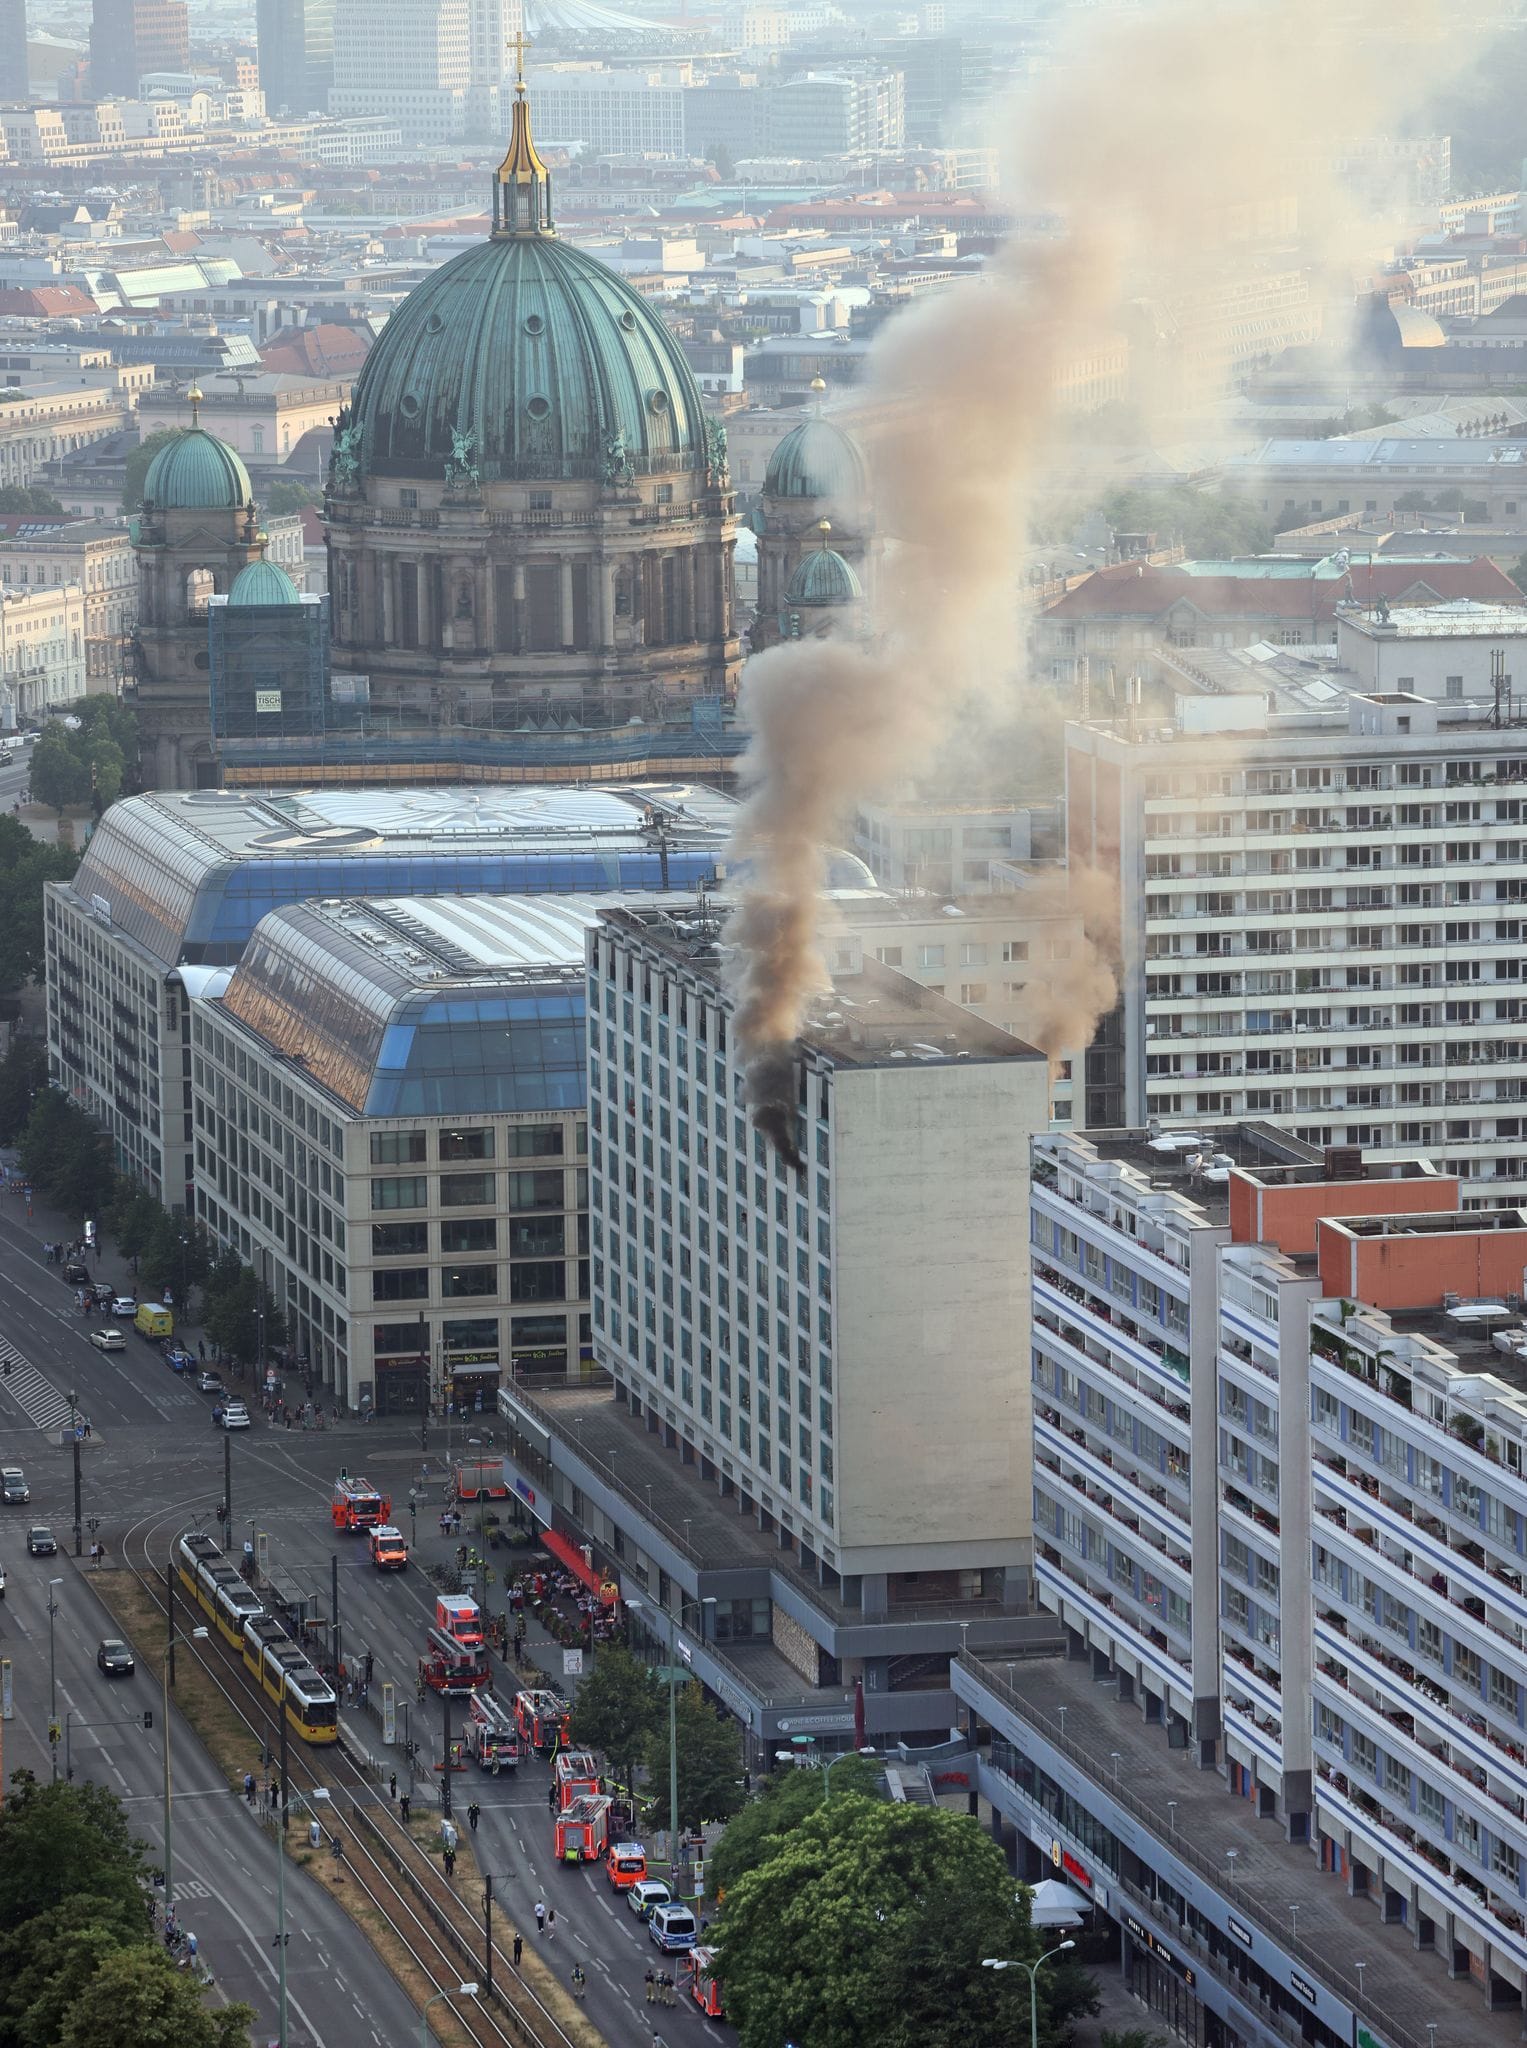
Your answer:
[330,0,471,141]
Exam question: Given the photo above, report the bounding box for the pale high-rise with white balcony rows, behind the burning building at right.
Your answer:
[1066,678,1527,1204]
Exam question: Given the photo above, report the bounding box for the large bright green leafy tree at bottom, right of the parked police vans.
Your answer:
[716,1788,1097,2048]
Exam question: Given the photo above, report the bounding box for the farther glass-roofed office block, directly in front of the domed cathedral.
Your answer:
[45,784,732,1208]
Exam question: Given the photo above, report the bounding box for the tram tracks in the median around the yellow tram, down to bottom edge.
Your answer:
[111,1497,592,2048]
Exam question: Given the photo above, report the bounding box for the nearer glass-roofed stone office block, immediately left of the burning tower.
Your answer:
[182,895,620,1415]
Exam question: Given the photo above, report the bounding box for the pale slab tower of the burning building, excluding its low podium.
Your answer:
[590,913,1048,1581]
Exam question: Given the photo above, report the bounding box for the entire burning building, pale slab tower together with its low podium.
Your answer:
[499,907,1048,1745]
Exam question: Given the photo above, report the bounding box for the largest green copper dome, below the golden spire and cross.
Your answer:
[350,231,706,483]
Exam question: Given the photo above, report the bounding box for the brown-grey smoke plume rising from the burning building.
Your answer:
[729,0,1457,1130]
